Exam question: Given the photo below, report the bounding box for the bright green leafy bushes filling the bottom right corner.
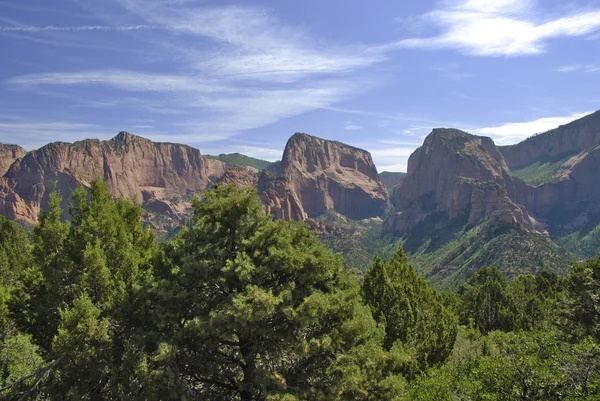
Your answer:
[409,332,600,401]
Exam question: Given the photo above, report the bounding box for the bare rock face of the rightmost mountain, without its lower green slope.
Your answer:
[499,111,600,235]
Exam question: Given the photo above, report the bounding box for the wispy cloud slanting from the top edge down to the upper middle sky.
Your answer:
[114,0,383,82]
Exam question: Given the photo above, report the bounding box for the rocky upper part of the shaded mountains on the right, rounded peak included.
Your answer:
[386,111,600,256]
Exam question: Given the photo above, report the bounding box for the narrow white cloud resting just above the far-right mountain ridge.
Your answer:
[472,111,590,145]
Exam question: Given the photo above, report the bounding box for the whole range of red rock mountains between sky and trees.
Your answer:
[0,113,600,288]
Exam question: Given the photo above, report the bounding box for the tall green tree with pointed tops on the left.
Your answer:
[21,179,156,400]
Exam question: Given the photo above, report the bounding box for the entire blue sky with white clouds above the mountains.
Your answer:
[0,0,600,171]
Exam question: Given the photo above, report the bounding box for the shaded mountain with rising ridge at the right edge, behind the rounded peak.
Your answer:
[499,111,600,258]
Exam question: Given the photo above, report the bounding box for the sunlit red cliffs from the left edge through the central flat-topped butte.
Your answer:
[0,132,389,227]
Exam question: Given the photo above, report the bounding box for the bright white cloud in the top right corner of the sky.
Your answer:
[386,0,600,56]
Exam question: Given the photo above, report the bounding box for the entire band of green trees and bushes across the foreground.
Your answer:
[0,180,600,401]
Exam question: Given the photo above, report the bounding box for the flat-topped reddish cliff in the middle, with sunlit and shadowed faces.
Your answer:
[259,133,390,220]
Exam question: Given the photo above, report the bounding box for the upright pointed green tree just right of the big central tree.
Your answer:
[362,248,457,366]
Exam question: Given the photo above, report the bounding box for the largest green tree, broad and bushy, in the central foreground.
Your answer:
[155,185,407,401]
